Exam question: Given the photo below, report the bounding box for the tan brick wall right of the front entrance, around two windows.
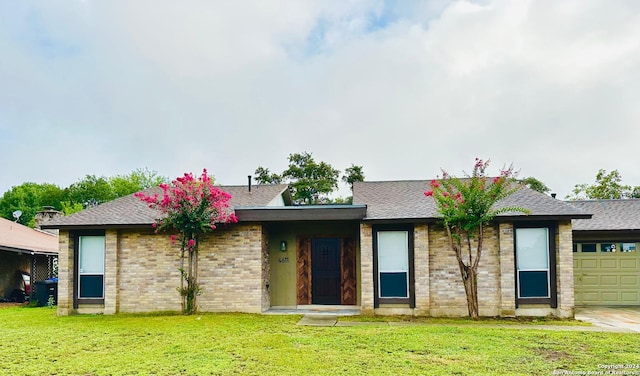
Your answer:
[360,221,573,317]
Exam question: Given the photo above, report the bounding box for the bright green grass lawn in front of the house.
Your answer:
[0,307,640,375]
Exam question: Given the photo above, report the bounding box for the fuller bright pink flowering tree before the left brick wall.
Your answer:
[135,169,238,314]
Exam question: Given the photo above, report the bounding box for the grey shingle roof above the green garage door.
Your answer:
[568,199,640,231]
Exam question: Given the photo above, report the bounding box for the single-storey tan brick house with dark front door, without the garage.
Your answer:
[43,181,590,317]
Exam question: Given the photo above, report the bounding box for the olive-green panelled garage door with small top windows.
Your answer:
[573,242,640,305]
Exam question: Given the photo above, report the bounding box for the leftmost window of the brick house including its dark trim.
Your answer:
[74,231,106,307]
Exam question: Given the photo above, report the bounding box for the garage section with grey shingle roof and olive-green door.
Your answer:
[570,199,640,306]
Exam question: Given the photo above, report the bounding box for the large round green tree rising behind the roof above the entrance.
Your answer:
[282,152,340,205]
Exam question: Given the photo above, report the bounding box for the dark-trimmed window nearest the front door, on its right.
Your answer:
[373,226,415,308]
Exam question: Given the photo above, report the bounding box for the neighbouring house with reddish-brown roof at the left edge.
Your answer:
[0,218,58,300]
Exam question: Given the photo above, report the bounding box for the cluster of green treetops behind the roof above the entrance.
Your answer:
[255,152,364,204]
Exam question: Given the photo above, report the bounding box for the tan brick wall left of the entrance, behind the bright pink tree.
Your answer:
[58,224,269,315]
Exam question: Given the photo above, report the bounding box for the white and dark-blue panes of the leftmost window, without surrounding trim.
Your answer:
[78,235,105,299]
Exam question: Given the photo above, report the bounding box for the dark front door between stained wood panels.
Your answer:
[311,238,341,304]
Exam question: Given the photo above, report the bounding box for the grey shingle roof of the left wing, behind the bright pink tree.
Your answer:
[42,184,287,228]
